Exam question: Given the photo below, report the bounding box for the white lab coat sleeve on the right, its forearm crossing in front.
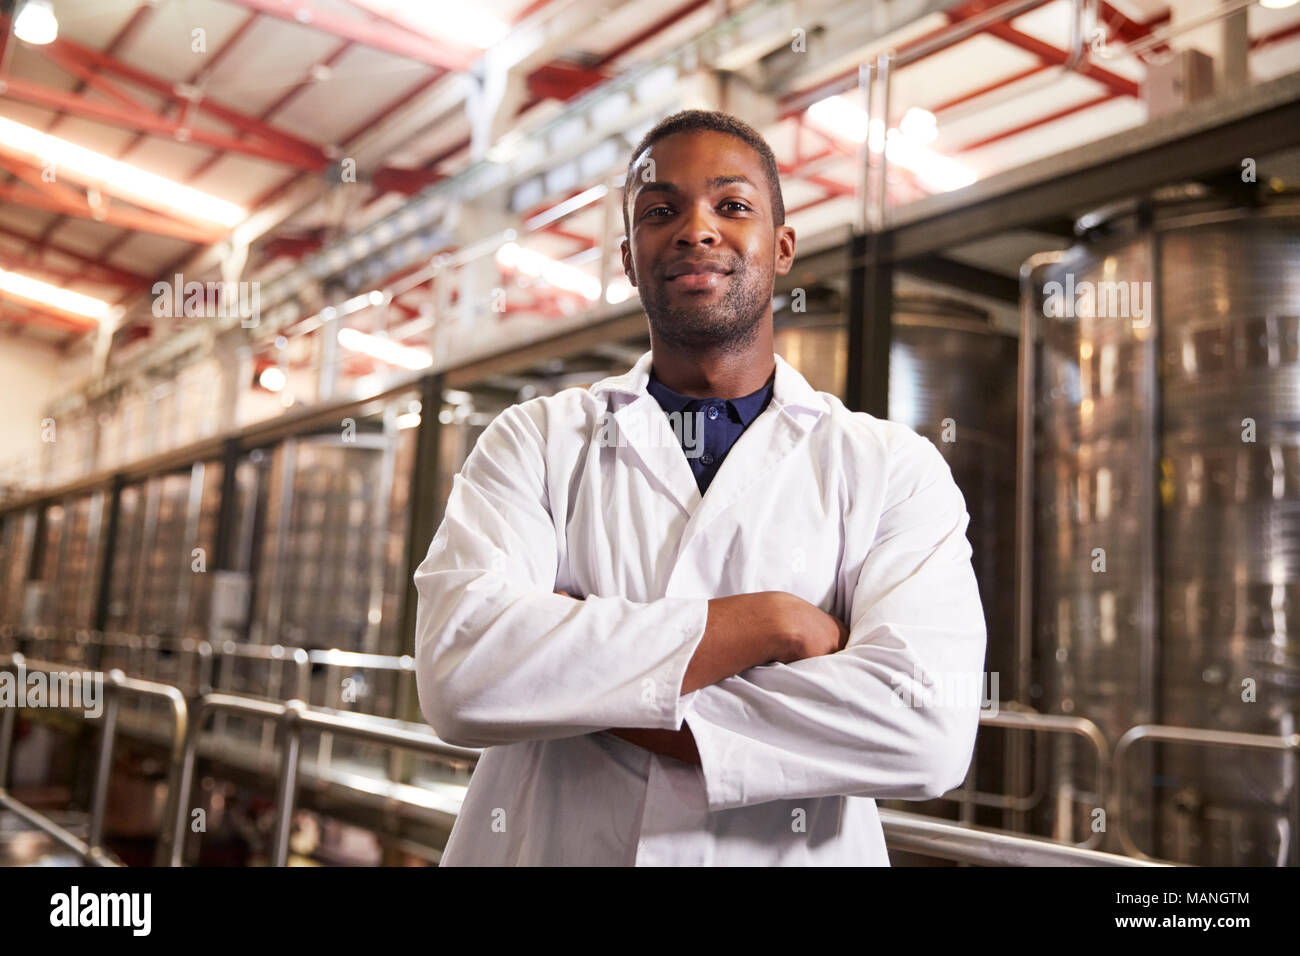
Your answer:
[686,432,987,810]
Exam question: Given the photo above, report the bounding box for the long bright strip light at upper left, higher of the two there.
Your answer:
[0,116,248,228]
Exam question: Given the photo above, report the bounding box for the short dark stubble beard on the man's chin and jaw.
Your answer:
[638,260,774,354]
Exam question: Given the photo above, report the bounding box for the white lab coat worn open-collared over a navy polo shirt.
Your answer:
[415,352,985,866]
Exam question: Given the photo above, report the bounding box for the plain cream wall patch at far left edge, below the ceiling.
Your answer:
[0,336,91,486]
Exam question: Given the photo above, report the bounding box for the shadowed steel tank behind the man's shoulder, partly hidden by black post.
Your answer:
[774,286,1017,826]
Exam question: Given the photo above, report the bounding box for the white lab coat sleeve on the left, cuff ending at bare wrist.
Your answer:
[415,399,709,747]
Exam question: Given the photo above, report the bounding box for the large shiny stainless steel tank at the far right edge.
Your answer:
[1032,190,1300,865]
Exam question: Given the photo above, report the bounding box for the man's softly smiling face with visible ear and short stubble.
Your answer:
[621,130,794,351]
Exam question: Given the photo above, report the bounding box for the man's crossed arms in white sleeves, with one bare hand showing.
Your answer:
[415,406,985,810]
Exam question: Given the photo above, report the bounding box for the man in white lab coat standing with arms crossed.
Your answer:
[415,111,985,866]
